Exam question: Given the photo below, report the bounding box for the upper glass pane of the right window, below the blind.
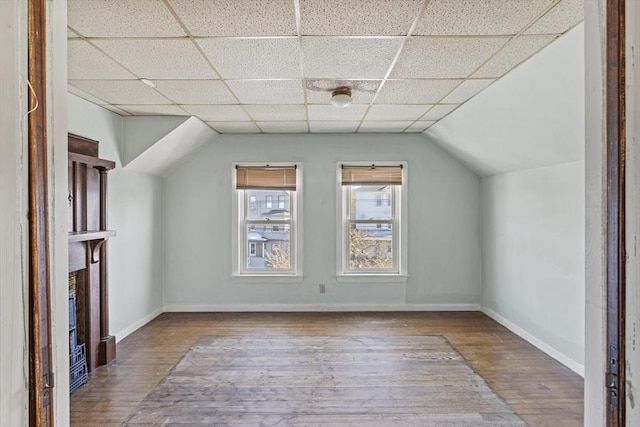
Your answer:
[349,185,393,219]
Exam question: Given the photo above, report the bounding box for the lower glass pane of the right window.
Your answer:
[349,222,393,270]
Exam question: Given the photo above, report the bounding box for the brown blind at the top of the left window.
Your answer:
[236,165,296,191]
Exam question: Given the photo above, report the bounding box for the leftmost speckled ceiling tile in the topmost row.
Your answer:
[67,0,185,37]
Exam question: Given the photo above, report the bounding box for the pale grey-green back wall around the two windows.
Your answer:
[164,135,480,310]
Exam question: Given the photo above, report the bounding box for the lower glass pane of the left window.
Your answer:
[245,224,291,270]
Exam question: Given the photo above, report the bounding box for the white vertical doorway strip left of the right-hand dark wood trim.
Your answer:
[584,0,607,427]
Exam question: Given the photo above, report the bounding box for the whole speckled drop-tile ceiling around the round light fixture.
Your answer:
[68,0,583,134]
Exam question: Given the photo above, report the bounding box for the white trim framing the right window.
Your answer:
[336,161,409,283]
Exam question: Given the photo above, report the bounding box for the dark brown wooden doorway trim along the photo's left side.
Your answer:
[27,0,53,426]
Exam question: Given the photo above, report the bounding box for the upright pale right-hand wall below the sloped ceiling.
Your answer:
[482,161,585,374]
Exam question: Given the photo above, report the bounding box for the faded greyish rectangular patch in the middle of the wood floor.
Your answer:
[123,336,526,427]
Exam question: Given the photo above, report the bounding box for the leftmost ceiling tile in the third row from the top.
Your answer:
[69,80,171,104]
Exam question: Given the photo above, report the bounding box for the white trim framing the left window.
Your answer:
[231,162,304,283]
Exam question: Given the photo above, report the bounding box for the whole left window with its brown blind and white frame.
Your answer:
[233,164,302,280]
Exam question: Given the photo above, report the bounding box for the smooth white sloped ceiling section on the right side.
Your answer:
[424,24,585,176]
